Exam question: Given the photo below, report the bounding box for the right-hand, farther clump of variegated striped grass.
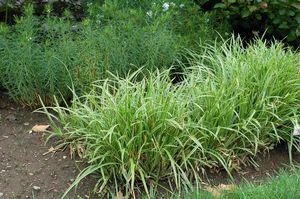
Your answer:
[187,39,300,171]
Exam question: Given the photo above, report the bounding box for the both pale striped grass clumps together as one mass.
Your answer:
[41,40,300,196]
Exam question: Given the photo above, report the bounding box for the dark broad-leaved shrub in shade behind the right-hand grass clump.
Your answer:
[199,0,300,45]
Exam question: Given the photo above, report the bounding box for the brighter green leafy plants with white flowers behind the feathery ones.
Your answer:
[88,0,230,48]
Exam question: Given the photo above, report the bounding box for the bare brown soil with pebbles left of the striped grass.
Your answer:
[0,92,95,199]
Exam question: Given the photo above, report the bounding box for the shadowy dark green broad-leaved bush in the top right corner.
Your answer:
[197,0,300,47]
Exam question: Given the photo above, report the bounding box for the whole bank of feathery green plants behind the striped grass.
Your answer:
[0,1,224,106]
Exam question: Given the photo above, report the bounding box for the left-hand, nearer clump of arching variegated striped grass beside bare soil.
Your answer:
[44,71,195,195]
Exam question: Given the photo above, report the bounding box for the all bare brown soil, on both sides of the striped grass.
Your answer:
[0,92,300,199]
